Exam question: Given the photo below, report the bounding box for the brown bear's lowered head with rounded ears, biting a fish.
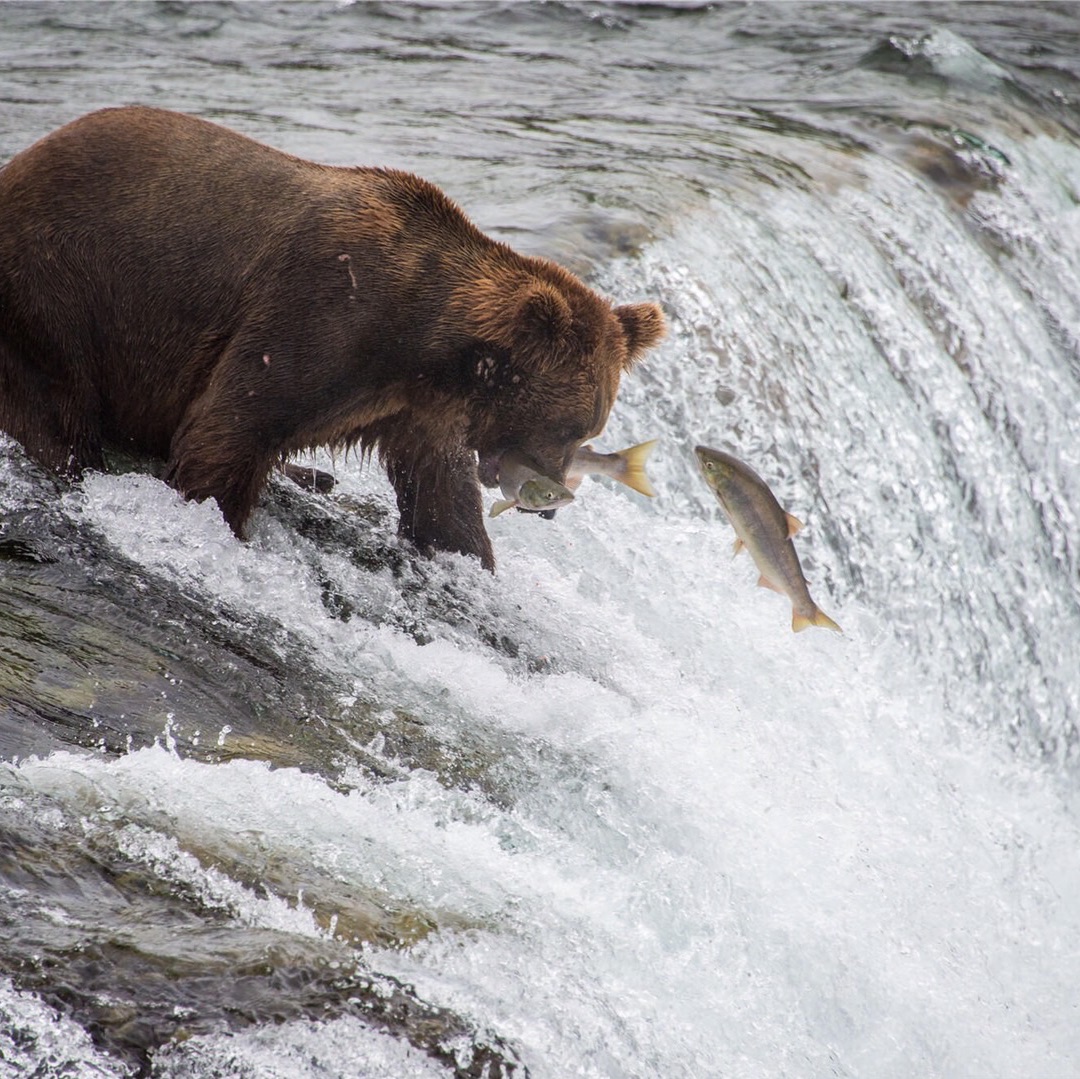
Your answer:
[449,259,665,486]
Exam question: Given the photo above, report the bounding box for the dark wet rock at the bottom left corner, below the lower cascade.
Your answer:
[0,773,528,1079]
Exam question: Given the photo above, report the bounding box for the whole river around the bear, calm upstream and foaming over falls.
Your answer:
[0,3,1080,1079]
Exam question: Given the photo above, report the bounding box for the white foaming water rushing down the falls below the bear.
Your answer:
[0,8,1080,1079]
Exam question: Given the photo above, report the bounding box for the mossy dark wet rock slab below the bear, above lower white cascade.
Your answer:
[0,514,535,805]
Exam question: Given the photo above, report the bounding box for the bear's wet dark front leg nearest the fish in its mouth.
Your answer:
[386,446,495,572]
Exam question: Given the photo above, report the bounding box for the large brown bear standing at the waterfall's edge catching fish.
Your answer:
[0,107,664,568]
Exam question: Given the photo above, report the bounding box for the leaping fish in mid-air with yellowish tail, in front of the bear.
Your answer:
[694,446,842,633]
